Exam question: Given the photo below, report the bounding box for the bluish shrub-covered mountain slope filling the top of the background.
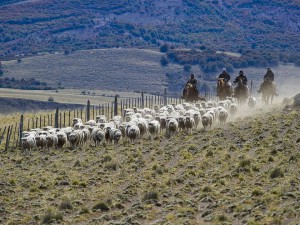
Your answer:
[0,0,300,62]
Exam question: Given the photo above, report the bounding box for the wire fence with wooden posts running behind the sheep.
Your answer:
[0,89,217,151]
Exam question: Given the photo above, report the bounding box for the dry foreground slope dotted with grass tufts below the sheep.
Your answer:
[0,103,300,224]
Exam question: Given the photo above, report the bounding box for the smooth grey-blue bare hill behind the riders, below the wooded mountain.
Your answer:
[0,48,300,96]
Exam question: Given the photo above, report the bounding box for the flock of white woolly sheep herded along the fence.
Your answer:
[21,98,256,151]
